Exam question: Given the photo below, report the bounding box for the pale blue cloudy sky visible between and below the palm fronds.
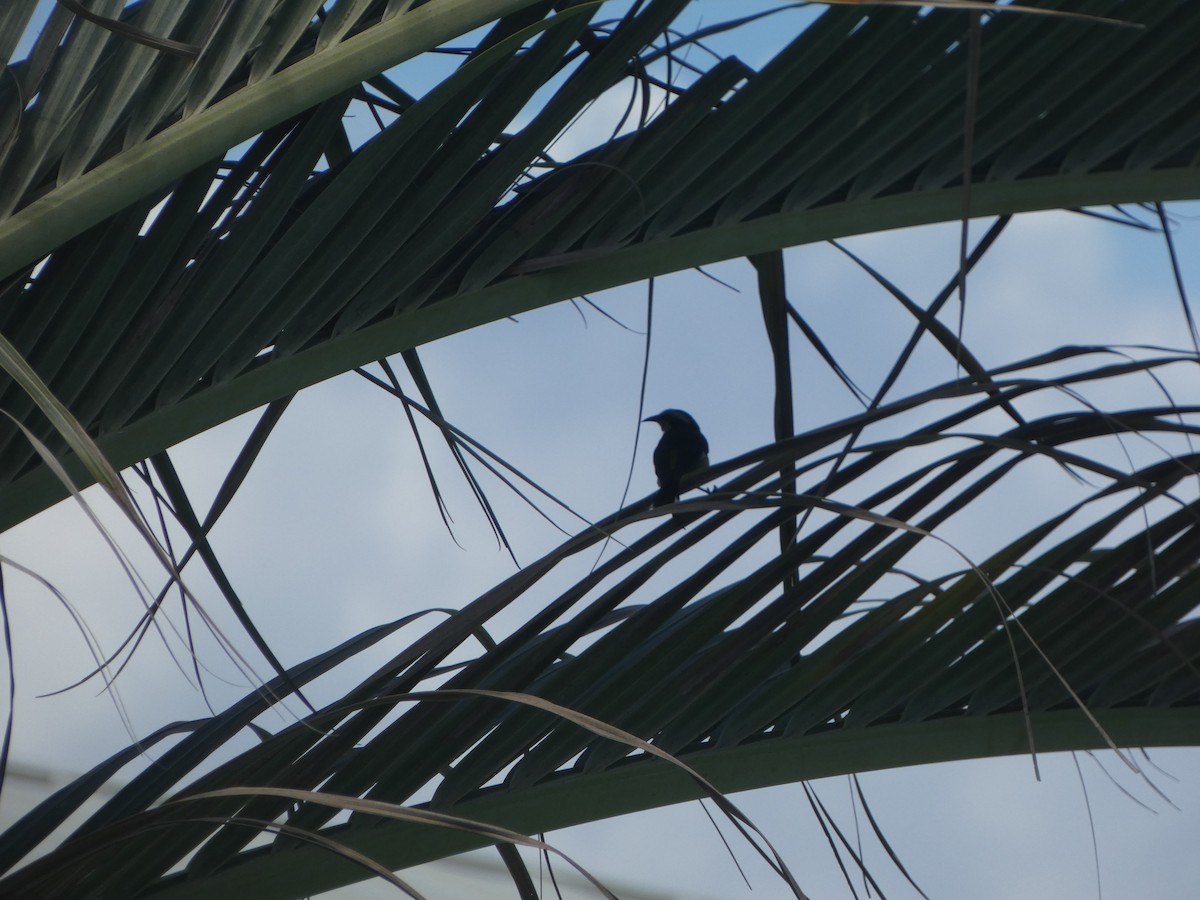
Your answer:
[0,3,1200,900]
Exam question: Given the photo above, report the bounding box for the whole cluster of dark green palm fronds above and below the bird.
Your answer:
[0,0,1200,896]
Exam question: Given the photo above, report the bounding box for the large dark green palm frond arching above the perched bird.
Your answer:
[0,0,1200,523]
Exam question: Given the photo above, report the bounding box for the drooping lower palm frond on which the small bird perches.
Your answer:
[0,349,1200,896]
